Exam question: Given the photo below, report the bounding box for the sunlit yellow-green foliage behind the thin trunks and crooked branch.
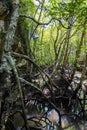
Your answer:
[19,0,87,65]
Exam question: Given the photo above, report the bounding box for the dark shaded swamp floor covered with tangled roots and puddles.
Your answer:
[1,62,87,130]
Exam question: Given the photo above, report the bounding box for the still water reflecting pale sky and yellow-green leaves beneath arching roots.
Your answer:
[24,100,87,130]
